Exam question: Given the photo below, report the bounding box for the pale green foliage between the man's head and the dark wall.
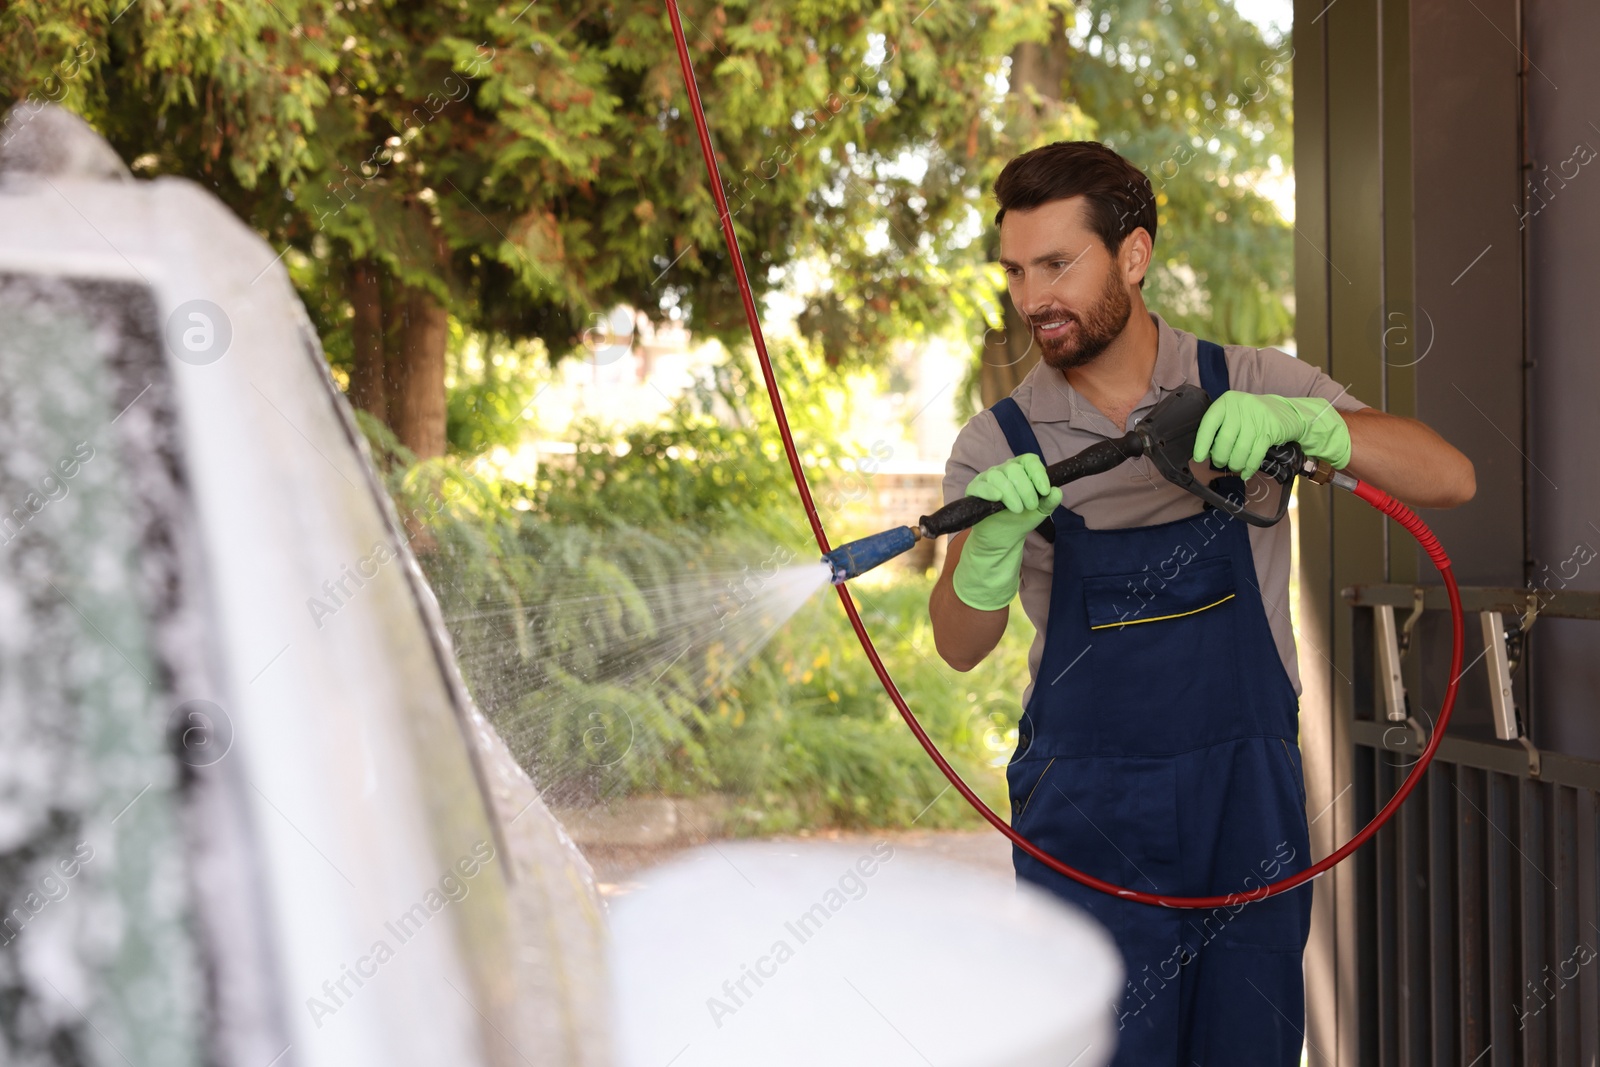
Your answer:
[1069,0,1294,346]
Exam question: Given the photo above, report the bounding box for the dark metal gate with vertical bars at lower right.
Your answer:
[1344,584,1600,1067]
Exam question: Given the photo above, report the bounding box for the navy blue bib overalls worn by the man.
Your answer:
[992,341,1310,1067]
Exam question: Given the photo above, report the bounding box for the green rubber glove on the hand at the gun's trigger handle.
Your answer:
[1194,389,1350,478]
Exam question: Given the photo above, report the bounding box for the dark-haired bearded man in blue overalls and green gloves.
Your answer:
[930,142,1475,1067]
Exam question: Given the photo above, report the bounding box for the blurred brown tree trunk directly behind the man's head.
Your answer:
[979,10,1069,408]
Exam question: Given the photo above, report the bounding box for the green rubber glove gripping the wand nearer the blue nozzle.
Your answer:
[950,453,1061,611]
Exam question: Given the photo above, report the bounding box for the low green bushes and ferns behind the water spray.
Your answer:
[362,376,1027,832]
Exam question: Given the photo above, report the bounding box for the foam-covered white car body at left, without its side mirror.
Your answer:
[0,104,610,1067]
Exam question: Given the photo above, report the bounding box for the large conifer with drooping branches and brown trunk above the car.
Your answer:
[0,0,1075,456]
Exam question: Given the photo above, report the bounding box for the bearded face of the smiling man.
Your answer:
[1000,197,1149,371]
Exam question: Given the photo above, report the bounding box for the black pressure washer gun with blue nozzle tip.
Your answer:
[822,386,1355,585]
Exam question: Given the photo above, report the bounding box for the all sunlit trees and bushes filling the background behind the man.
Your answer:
[0,0,1294,832]
